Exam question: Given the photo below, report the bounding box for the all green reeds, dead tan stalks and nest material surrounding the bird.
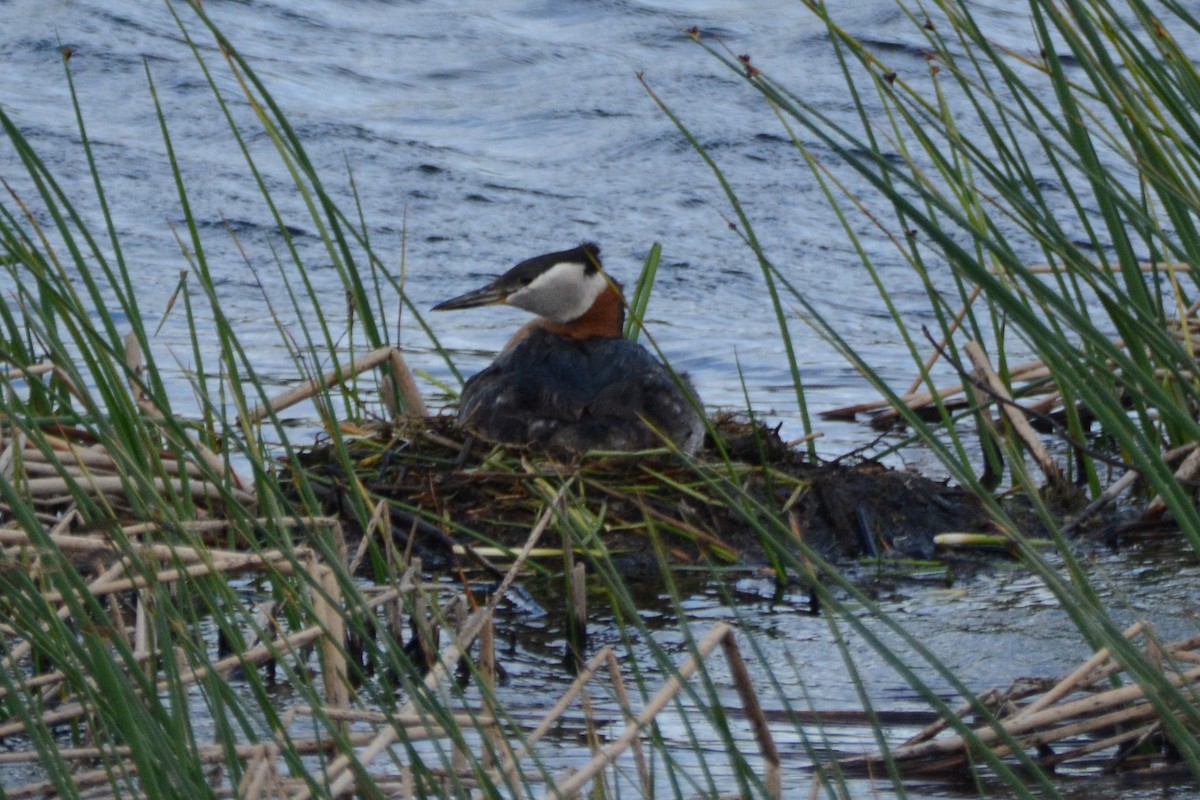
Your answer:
[0,0,1200,798]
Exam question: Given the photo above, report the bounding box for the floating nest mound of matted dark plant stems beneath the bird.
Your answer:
[283,414,990,569]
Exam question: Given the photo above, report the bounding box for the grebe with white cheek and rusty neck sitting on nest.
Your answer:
[433,242,704,453]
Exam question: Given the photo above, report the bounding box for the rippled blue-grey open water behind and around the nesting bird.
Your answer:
[0,0,1195,796]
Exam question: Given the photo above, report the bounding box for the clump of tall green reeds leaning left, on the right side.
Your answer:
[656,0,1200,791]
